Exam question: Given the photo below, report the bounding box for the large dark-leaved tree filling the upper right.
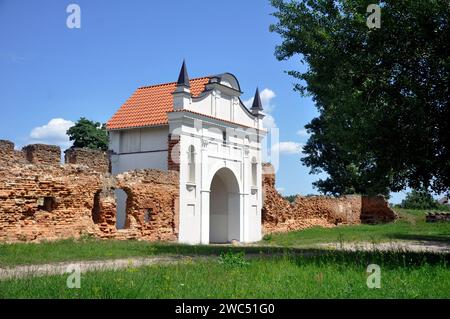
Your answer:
[270,0,450,195]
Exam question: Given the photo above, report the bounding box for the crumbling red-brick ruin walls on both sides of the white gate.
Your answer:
[0,140,395,242]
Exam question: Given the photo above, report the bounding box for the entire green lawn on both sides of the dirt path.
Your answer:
[0,210,450,298]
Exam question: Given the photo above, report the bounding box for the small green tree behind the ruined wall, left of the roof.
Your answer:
[67,117,108,151]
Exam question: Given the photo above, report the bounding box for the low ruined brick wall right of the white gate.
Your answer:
[262,164,397,233]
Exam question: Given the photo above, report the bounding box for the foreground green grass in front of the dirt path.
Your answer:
[0,252,450,298]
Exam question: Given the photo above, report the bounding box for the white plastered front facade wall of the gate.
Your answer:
[169,92,263,244]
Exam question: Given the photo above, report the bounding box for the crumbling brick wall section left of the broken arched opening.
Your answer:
[0,164,101,242]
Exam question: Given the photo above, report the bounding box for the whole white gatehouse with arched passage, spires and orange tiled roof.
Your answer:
[107,62,267,244]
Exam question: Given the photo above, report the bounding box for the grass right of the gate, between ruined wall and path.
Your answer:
[263,209,450,247]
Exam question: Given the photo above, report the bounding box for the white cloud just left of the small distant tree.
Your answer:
[29,118,75,149]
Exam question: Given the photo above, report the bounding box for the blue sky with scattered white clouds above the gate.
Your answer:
[0,0,403,202]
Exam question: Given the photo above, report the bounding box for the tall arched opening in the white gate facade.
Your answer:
[209,168,240,243]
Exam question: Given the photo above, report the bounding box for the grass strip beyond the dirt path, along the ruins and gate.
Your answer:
[0,210,450,267]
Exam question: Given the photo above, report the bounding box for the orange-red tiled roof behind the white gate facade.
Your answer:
[106,77,210,130]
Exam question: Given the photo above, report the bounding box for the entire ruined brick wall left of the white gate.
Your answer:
[0,141,179,242]
